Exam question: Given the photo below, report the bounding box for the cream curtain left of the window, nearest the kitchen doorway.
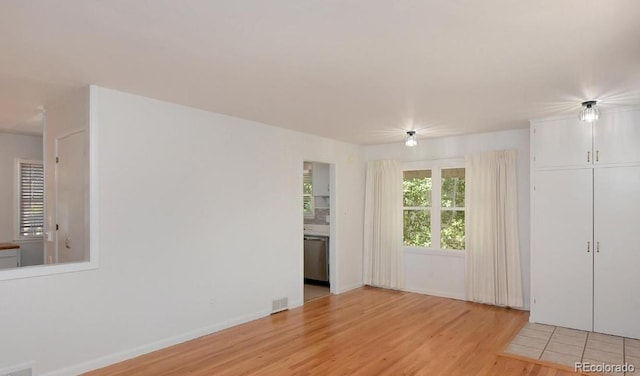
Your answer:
[364,161,404,289]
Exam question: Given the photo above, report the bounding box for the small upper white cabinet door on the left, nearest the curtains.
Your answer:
[532,117,593,168]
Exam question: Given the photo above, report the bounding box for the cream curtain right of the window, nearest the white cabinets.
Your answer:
[465,150,523,307]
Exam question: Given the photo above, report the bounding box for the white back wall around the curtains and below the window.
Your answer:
[364,129,530,309]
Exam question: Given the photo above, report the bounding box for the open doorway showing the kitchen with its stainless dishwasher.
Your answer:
[302,161,334,303]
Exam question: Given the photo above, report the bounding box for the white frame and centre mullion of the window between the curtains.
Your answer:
[402,158,467,255]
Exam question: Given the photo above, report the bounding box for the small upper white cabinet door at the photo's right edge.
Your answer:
[593,110,640,164]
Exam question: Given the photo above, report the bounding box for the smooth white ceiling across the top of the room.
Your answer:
[0,0,640,144]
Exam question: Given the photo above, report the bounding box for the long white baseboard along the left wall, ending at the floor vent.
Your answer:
[43,311,271,376]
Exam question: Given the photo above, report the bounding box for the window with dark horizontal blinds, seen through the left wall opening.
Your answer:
[16,159,44,239]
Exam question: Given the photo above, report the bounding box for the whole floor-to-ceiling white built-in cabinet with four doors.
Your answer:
[531,110,640,338]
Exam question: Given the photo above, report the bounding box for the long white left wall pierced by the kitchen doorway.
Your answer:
[0,89,365,374]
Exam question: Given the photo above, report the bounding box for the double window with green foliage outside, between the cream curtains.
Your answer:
[403,167,465,250]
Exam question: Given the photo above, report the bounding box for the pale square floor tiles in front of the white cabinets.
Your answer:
[505,323,640,375]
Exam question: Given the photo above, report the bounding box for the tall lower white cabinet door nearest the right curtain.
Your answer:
[531,169,593,330]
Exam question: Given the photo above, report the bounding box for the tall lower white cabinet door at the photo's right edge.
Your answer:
[593,167,640,338]
